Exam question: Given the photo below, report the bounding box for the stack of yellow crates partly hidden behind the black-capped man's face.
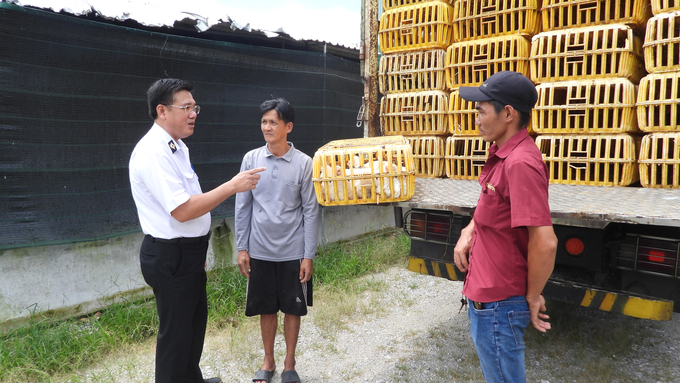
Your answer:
[445,0,541,179]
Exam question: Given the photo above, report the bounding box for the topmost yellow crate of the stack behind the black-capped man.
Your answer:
[453,0,541,42]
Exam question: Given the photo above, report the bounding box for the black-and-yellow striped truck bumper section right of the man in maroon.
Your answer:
[543,279,673,320]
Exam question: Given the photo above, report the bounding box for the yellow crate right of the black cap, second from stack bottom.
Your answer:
[531,78,638,134]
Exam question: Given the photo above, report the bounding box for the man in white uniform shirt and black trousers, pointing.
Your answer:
[129,79,264,383]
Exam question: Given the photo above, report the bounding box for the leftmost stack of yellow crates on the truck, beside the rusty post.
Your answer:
[378,0,454,177]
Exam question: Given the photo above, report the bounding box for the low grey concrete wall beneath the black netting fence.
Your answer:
[0,205,394,329]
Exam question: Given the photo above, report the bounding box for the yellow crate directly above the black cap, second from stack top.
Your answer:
[445,35,531,90]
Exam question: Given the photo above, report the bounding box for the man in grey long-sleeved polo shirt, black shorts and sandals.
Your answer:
[236,98,319,383]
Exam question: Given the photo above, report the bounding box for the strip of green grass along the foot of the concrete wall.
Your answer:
[0,230,410,382]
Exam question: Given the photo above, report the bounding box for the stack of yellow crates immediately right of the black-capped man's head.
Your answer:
[530,0,651,186]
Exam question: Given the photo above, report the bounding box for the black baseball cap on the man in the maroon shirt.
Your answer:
[458,71,538,113]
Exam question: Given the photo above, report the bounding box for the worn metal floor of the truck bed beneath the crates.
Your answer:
[394,177,680,228]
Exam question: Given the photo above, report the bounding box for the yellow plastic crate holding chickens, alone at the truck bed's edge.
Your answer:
[312,136,415,206]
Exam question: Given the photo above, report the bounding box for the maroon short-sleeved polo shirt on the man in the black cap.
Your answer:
[463,129,552,302]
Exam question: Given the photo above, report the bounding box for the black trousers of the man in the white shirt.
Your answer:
[139,235,209,383]
